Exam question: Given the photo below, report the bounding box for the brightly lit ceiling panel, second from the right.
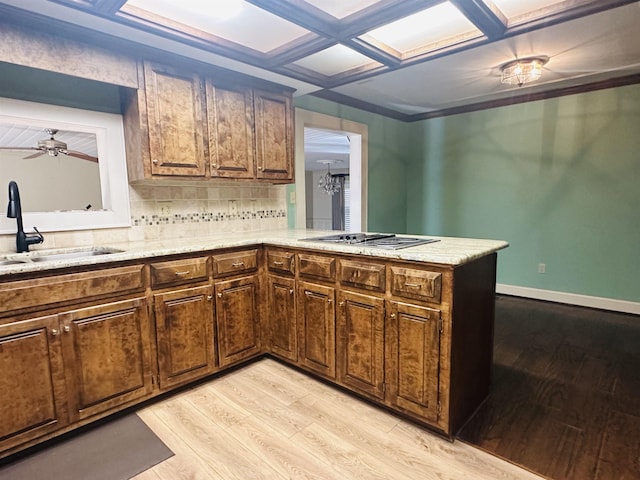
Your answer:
[363,2,482,53]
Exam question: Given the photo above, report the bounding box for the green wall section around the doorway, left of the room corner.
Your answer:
[295,95,410,232]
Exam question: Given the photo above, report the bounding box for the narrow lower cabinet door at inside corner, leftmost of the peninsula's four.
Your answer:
[268,275,298,362]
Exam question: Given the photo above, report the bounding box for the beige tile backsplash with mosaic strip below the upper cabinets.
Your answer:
[0,182,287,252]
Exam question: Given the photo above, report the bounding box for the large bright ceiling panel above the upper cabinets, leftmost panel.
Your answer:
[121,0,309,53]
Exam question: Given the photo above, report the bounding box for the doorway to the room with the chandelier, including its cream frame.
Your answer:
[295,109,368,231]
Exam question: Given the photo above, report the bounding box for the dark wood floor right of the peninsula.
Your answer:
[459,296,640,480]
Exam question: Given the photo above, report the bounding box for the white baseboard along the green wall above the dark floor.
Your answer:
[496,283,640,315]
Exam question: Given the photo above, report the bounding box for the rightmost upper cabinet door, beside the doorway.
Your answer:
[253,90,293,180]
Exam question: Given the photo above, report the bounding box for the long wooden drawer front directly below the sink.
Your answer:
[0,265,145,314]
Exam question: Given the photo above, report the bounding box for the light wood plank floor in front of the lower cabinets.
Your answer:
[135,359,542,480]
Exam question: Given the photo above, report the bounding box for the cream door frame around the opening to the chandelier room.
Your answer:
[295,108,369,232]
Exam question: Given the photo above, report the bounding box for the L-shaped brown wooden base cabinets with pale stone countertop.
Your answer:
[0,230,507,456]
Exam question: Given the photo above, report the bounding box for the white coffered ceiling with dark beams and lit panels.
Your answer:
[0,0,640,120]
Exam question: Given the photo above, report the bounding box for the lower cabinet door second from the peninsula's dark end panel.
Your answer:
[337,292,384,398]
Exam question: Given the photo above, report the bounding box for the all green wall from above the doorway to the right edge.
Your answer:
[296,85,640,301]
